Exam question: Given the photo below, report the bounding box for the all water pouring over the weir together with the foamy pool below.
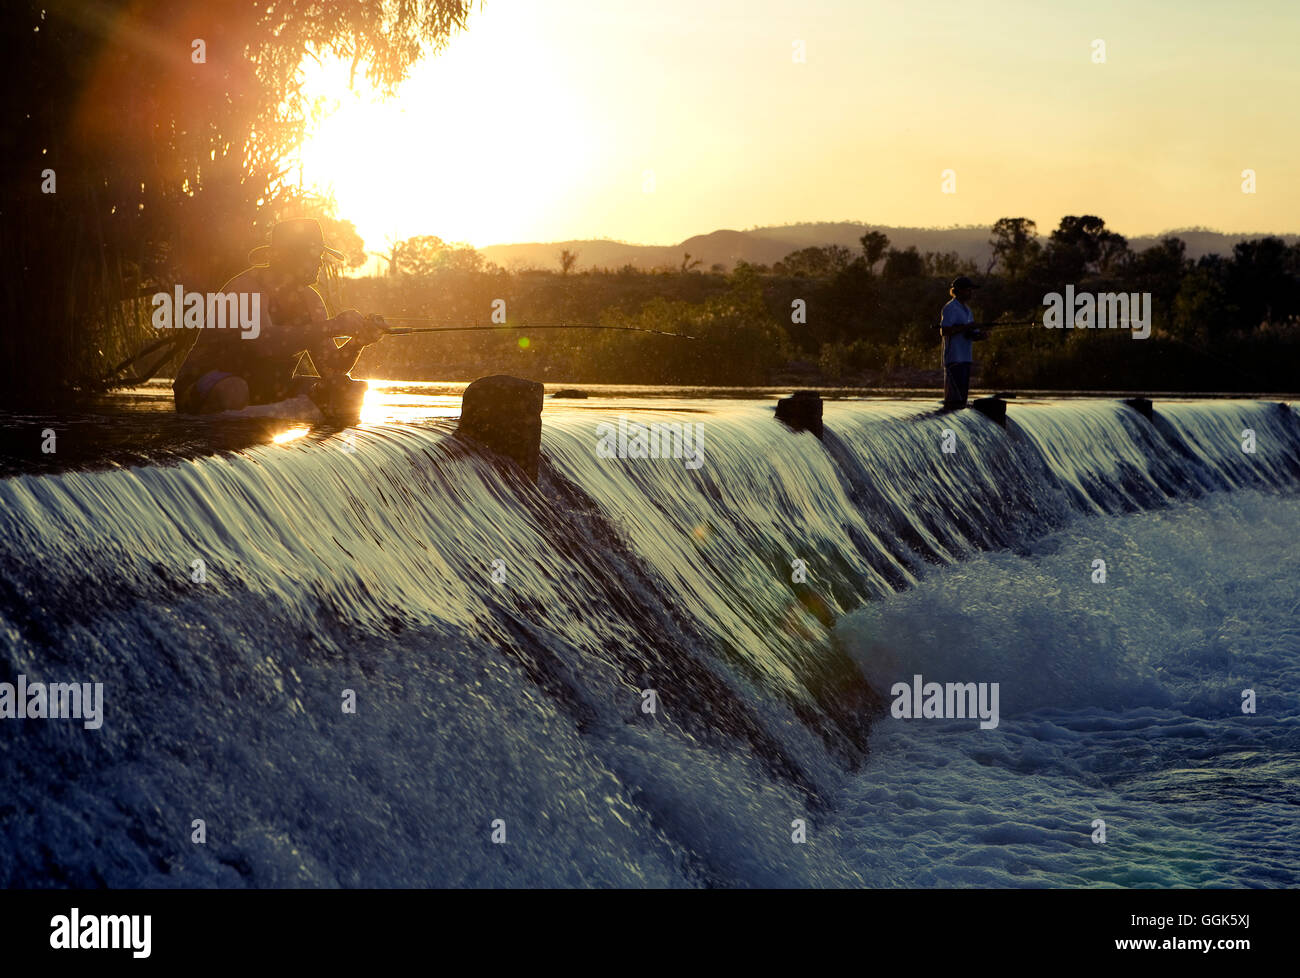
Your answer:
[0,387,1300,886]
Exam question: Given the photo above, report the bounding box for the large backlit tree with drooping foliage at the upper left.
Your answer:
[0,0,472,399]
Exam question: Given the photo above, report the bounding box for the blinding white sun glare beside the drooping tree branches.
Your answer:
[300,21,594,257]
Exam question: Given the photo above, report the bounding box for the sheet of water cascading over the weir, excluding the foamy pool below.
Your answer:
[0,399,1300,886]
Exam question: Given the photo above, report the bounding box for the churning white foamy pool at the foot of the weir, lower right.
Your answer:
[839,493,1300,886]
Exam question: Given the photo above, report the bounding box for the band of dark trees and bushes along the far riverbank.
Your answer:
[351,215,1300,390]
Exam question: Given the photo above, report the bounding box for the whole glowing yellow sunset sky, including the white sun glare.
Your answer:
[303,0,1300,248]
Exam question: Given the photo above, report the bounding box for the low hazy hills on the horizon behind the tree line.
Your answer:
[480,221,1300,271]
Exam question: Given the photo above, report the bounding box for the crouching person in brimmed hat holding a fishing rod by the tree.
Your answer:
[172,218,384,414]
